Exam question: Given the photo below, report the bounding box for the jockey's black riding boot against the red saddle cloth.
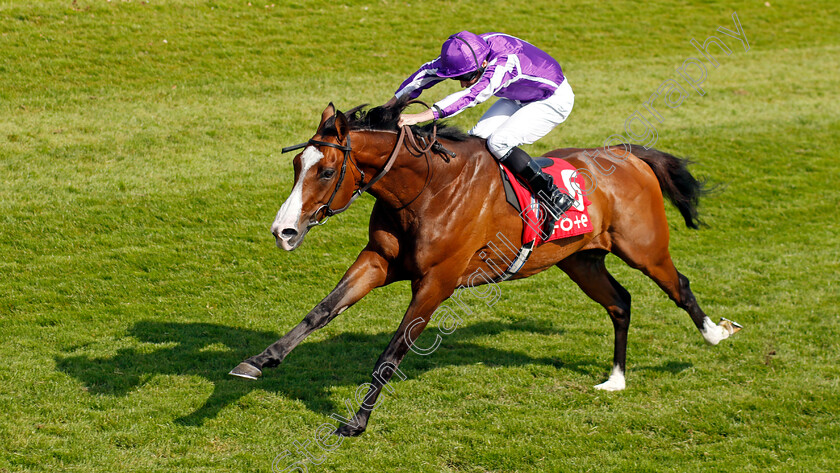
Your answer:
[501,148,575,238]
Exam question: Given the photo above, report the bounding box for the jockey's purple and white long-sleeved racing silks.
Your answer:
[394,33,564,119]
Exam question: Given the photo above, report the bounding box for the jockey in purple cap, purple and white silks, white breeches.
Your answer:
[385,31,575,235]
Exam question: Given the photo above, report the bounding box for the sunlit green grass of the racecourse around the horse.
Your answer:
[0,0,840,472]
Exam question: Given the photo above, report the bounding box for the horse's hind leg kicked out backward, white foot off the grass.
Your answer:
[613,242,741,345]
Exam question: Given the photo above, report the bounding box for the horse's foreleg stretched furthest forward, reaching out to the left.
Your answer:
[230,249,393,379]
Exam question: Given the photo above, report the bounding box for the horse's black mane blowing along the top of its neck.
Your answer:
[321,100,469,141]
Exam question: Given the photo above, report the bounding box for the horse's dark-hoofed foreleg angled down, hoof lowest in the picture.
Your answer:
[335,276,455,436]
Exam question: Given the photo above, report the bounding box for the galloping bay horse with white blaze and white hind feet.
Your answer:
[230,103,740,436]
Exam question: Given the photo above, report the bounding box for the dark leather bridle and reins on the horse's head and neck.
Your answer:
[281,100,455,229]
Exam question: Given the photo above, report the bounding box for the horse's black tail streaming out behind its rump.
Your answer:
[630,145,710,228]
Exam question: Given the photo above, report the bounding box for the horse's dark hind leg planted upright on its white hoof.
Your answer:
[557,250,630,391]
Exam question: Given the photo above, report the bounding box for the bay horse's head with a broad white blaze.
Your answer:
[271,104,360,251]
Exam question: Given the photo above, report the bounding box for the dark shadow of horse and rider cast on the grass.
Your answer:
[56,321,600,425]
